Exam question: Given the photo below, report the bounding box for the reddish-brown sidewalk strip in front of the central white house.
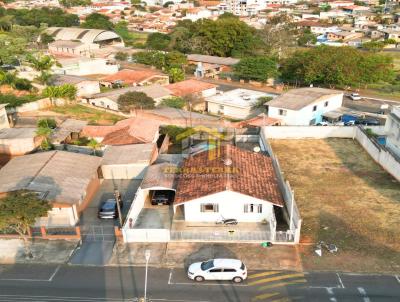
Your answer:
[108,242,302,271]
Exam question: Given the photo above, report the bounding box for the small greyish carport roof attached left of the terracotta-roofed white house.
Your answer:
[140,163,177,190]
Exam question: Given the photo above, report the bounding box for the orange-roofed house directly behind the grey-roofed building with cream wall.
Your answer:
[81,117,160,145]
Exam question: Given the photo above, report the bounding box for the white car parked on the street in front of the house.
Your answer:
[188,259,247,283]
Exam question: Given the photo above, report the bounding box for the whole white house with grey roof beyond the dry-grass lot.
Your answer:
[265,87,343,125]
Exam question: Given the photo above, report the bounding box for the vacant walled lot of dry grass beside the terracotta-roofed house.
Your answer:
[271,139,400,272]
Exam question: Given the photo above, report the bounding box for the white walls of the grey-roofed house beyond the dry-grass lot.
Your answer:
[268,93,343,126]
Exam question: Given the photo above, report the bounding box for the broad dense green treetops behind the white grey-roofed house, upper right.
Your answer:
[281,46,395,86]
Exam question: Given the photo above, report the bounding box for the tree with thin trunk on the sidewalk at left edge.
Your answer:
[0,191,51,258]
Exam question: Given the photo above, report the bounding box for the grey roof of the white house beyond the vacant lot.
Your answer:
[265,87,343,110]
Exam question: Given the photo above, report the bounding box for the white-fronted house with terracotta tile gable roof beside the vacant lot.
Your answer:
[174,145,284,223]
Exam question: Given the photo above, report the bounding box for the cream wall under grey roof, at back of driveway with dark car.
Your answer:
[101,162,149,179]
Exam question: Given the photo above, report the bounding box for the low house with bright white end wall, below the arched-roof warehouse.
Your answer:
[51,74,100,97]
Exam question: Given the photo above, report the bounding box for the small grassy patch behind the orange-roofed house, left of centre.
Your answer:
[47,105,124,125]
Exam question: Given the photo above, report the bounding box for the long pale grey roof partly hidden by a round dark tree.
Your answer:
[92,84,171,102]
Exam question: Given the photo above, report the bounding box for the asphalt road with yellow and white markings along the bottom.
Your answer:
[0,265,400,302]
